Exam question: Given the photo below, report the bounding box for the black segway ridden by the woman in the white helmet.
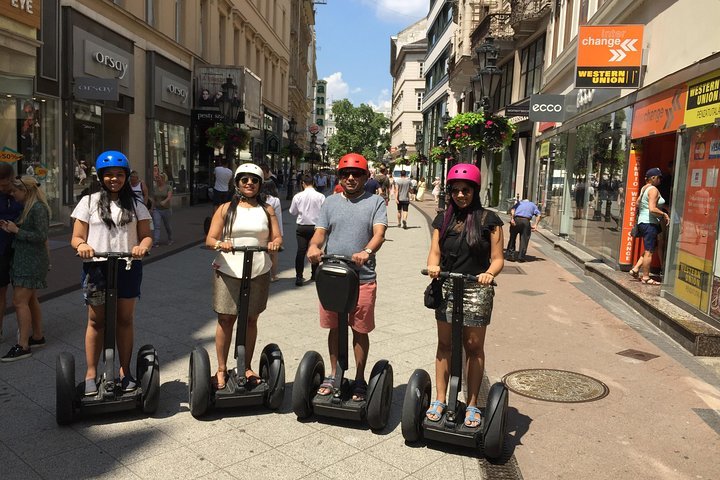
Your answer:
[188,247,285,418]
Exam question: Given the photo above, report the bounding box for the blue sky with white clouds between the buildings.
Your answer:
[315,0,430,111]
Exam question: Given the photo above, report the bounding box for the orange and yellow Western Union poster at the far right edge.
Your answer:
[674,128,720,311]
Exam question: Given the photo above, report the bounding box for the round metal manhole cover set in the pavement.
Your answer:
[503,368,610,403]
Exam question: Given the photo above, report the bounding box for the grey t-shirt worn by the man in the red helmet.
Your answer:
[315,192,387,283]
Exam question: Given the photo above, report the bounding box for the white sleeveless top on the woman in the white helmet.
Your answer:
[213,206,271,278]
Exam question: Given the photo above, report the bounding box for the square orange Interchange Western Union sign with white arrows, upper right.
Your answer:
[575,25,643,88]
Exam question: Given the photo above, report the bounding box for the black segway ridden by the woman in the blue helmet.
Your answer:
[55,252,160,425]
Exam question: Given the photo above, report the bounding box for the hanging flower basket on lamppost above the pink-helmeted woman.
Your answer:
[447,112,515,151]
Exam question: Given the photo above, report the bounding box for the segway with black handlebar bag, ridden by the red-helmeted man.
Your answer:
[292,255,393,430]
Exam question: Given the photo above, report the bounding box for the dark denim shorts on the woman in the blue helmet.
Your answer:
[80,260,142,306]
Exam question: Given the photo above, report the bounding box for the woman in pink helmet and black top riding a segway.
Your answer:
[427,164,504,428]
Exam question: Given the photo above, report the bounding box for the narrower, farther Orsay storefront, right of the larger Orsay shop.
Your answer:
[144,52,191,206]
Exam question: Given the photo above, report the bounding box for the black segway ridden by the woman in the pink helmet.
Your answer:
[401,270,508,459]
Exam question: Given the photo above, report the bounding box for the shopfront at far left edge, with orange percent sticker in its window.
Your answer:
[0,2,60,222]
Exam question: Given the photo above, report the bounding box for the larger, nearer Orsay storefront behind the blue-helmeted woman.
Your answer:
[62,8,135,212]
